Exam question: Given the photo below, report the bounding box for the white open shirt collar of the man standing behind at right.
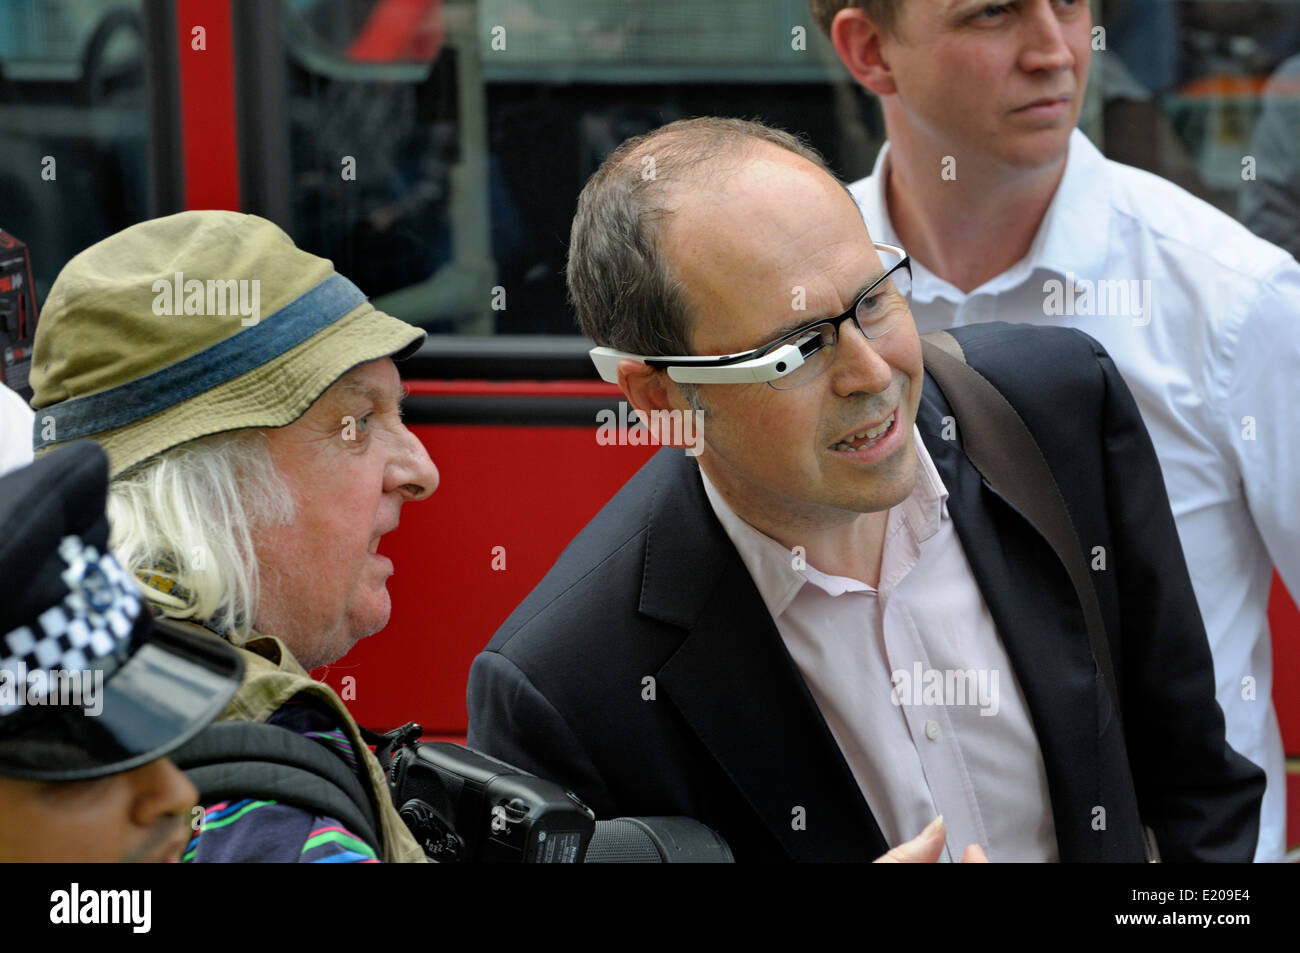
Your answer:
[850,129,1112,302]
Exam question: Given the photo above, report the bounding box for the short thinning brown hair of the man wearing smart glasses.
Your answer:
[567,117,835,355]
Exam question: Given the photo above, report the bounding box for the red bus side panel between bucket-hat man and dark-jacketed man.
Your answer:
[315,421,657,735]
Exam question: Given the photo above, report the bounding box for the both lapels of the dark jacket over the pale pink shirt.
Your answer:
[640,371,1110,861]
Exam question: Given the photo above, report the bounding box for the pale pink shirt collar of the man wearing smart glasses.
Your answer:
[699,425,948,619]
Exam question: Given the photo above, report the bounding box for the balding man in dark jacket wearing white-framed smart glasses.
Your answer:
[468,120,1262,862]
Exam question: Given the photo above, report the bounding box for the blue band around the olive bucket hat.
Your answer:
[31,267,365,450]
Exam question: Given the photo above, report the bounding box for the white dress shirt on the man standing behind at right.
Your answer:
[852,130,1300,861]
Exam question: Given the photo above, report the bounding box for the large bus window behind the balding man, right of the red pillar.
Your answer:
[254,0,883,335]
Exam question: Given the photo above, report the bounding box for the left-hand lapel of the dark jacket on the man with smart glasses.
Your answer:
[640,451,888,861]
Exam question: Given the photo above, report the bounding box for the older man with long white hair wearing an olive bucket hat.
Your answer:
[31,211,438,862]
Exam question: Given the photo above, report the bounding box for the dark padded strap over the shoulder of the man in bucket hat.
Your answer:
[169,722,384,857]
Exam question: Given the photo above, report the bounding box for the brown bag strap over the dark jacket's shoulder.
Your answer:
[922,332,1122,724]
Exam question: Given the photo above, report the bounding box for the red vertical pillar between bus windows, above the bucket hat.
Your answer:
[176,0,239,212]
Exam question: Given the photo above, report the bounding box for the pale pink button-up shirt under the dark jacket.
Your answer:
[701,428,1060,861]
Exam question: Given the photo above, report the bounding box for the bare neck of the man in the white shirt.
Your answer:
[884,131,1066,294]
